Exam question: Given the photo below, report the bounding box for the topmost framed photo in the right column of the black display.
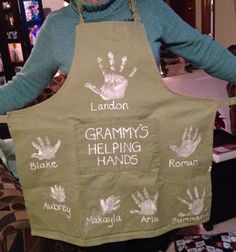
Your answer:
[23,0,40,22]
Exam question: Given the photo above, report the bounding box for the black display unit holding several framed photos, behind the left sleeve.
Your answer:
[0,0,44,80]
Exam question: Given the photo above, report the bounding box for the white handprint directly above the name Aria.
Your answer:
[130,188,158,215]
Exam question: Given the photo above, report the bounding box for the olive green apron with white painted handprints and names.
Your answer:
[0,0,236,246]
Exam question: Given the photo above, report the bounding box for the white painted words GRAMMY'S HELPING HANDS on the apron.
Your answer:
[84,124,150,166]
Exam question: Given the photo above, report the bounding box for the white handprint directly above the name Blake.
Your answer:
[31,136,61,160]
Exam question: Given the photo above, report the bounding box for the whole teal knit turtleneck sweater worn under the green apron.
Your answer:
[0,0,236,114]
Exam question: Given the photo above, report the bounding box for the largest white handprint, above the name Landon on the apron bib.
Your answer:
[85,52,137,100]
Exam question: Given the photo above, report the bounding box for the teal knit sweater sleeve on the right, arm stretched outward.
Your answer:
[154,0,236,83]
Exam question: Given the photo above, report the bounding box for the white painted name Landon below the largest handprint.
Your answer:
[90,100,129,112]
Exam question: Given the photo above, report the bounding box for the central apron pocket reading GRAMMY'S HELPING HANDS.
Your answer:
[76,119,160,174]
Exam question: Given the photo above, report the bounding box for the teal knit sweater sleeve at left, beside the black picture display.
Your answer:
[0,13,58,114]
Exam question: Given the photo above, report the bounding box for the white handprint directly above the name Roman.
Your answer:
[170,126,201,158]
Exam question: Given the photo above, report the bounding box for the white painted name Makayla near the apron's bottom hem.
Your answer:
[86,214,122,228]
